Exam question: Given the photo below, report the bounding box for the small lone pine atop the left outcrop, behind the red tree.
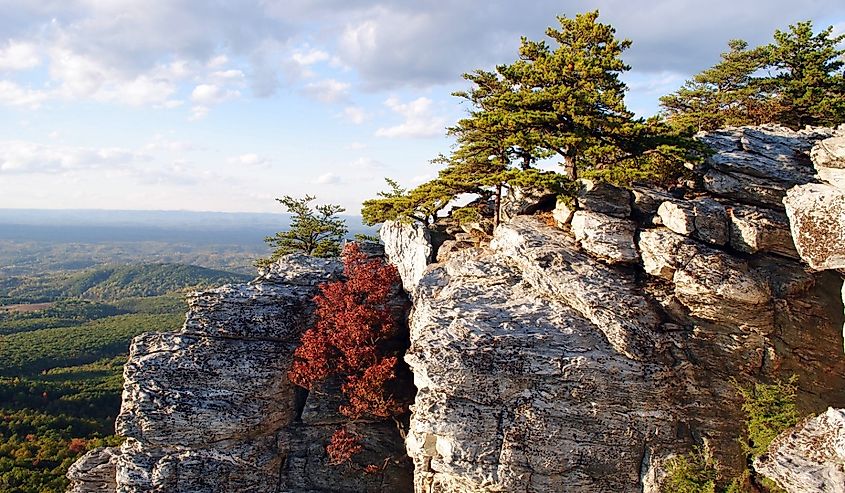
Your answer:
[257,195,348,266]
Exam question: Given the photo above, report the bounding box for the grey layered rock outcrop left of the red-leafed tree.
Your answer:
[69,256,410,493]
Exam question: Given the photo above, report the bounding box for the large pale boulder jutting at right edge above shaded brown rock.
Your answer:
[783,183,845,270]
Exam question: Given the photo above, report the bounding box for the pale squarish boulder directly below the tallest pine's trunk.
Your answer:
[572,211,640,263]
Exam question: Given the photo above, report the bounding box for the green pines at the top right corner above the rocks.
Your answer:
[660,21,845,131]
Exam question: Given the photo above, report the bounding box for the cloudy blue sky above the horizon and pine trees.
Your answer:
[0,0,845,214]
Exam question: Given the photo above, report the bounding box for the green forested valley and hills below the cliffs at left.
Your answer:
[0,264,248,493]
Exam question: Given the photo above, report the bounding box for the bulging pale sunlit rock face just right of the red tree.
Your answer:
[406,216,673,492]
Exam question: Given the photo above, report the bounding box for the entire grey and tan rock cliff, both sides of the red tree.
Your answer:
[69,126,845,493]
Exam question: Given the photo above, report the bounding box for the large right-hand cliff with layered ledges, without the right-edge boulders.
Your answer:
[384,127,845,493]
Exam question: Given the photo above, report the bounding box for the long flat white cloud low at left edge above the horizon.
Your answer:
[0,141,150,174]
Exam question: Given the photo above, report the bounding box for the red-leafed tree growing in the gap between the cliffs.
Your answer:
[288,243,408,463]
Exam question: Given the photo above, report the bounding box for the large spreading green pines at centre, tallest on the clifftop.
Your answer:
[362,11,701,224]
